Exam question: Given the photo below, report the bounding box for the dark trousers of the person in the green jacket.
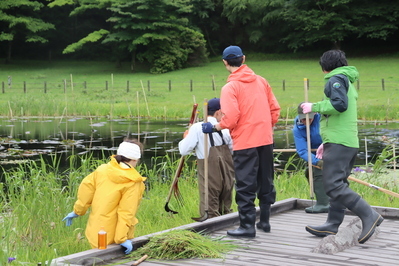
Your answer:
[323,143,360,209]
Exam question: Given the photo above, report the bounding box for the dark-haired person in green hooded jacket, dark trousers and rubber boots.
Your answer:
[301,50,384,244]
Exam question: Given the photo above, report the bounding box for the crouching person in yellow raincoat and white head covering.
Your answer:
[63,139,146,254]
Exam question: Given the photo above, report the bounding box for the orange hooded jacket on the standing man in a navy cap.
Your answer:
[219,64,280,151]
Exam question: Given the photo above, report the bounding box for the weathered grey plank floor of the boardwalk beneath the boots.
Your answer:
[111,202,399,266]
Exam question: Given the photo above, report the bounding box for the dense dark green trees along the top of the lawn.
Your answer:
[0,0,399,73]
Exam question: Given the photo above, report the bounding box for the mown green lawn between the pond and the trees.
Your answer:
[0,54,399,120]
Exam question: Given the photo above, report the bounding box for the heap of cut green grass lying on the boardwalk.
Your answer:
[132,230,236,260]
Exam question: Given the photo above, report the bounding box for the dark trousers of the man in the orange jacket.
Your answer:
[233,144,276,214]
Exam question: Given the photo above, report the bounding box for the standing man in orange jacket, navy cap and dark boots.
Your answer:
[202,46,280,237]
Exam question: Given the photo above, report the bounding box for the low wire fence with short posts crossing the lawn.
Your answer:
[1,78,399,94]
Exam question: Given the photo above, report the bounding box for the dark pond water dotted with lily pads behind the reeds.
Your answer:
[0,118,399,172]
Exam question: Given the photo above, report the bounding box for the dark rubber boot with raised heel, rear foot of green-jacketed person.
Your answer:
[350,198,384,244]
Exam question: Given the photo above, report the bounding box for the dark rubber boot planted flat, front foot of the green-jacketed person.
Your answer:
[306,206,345,237]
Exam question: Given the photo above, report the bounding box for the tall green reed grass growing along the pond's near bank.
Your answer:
[0,151,399,265]
